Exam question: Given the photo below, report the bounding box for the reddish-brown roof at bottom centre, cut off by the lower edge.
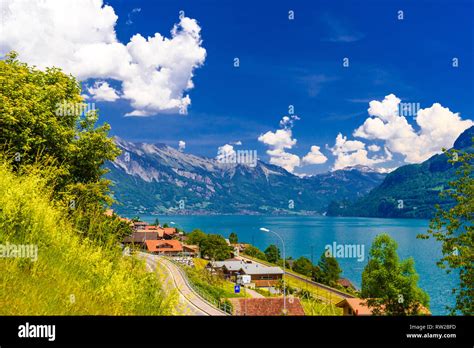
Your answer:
[229,297,305,316]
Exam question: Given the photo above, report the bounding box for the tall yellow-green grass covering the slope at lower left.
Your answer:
[0,161,177,315]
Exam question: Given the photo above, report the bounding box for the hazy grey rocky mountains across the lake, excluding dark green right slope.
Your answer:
[107,137,385,215]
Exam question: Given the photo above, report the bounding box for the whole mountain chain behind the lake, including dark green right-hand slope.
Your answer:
[107,127,474,218]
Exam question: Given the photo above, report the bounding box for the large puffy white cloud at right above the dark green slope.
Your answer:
[353,94,474,163]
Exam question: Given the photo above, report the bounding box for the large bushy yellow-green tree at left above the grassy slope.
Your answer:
[0,52,120,211]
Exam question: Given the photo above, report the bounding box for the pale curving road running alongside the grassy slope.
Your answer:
[139,253,225,316]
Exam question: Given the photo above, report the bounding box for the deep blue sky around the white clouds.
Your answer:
[3,0,474,174]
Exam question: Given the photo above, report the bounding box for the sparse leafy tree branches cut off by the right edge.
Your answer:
[418,147,474,315]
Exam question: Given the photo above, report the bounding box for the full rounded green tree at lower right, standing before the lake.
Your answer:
[361,234,429,315]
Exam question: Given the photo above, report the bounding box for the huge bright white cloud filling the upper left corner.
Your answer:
[0,0,206,116]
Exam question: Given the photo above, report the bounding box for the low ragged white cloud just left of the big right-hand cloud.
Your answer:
[329,133,392,170]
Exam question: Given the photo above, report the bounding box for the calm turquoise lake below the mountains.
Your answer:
[137,215,457,315]
